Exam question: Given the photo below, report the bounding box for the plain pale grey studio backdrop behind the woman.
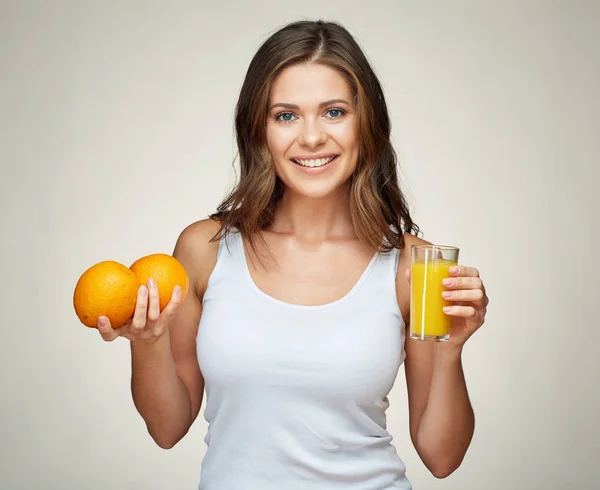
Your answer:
[0,0,600,490]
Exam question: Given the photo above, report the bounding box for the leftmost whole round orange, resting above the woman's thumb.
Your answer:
[73,260,140,328]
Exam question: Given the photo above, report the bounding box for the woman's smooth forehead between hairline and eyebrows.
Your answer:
[269,63,352,106]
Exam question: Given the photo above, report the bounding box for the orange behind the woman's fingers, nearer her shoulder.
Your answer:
[129,253,189,311]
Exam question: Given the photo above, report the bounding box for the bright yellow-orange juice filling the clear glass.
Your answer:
[410,258,457,340]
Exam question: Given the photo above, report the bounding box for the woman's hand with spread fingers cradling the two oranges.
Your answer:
[97,279,181,343]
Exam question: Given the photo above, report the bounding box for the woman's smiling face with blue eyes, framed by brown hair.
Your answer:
[267,64,359,198]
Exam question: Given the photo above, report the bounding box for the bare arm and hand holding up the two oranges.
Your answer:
[99,220,218,449]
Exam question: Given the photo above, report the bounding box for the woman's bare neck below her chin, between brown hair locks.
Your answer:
[272,186,355,243]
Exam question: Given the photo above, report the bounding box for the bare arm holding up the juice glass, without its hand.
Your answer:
[397,236,475,478]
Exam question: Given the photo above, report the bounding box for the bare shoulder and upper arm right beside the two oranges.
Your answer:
[173,218,221,298]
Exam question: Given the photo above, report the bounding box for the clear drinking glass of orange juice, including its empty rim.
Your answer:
[410,245,459,342]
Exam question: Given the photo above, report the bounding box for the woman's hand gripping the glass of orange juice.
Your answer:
[442,266,489,348]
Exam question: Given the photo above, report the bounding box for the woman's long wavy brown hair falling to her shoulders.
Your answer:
[211,20,419,252]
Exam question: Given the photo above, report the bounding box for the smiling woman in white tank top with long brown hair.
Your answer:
[98,22,487,490]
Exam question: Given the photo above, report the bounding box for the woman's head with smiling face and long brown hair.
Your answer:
[212,22,419,252]
